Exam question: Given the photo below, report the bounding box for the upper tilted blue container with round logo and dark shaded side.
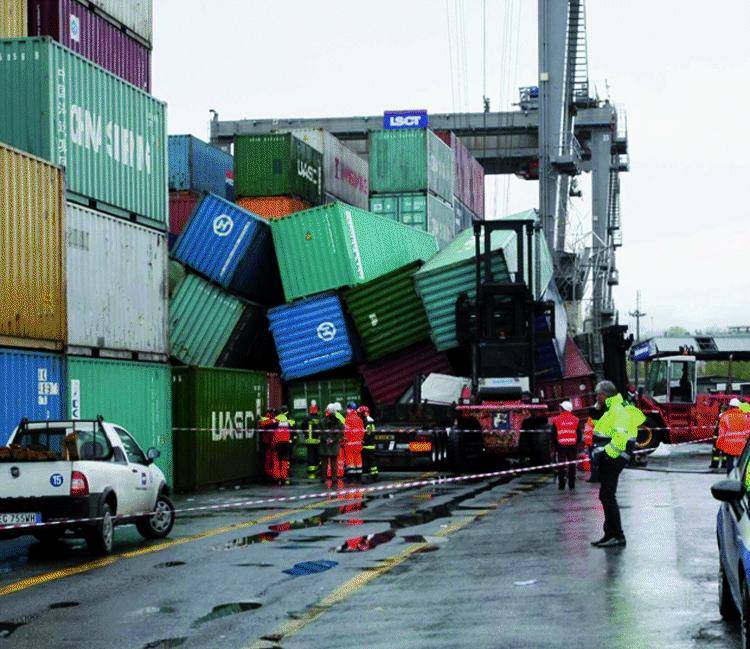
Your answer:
[172,194,283,304]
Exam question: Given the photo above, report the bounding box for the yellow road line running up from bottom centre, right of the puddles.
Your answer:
[246,476,549,649]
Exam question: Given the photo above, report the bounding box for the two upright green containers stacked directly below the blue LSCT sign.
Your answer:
[368,129,456,248]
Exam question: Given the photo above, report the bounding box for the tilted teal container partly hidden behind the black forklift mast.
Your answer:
[414,210,552,351]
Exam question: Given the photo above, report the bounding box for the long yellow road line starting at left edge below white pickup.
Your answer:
[0,472,435,597]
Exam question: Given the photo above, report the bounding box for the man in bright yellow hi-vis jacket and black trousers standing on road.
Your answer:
[591,381,646,548]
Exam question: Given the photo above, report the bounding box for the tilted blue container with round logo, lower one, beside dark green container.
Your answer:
[268,295,354,381]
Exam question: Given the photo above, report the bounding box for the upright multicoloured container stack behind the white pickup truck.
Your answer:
[0,0,172,482]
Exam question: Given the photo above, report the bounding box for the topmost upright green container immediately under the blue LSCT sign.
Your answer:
[369,129,455,202]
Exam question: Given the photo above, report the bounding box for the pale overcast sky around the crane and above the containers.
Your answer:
[153,0,750,329]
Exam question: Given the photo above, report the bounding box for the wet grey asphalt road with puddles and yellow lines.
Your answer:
[0,447,739,649]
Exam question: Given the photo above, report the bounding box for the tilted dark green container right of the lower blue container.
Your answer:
[344,262,430,362]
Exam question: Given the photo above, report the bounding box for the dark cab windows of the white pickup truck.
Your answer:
[13,422,112,460]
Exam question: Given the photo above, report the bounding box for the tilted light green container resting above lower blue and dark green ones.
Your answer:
[271,202,438,302]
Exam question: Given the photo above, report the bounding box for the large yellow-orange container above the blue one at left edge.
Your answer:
[0,139,66,349]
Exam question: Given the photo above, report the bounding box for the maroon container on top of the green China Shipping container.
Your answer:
[28,0,151,92]
